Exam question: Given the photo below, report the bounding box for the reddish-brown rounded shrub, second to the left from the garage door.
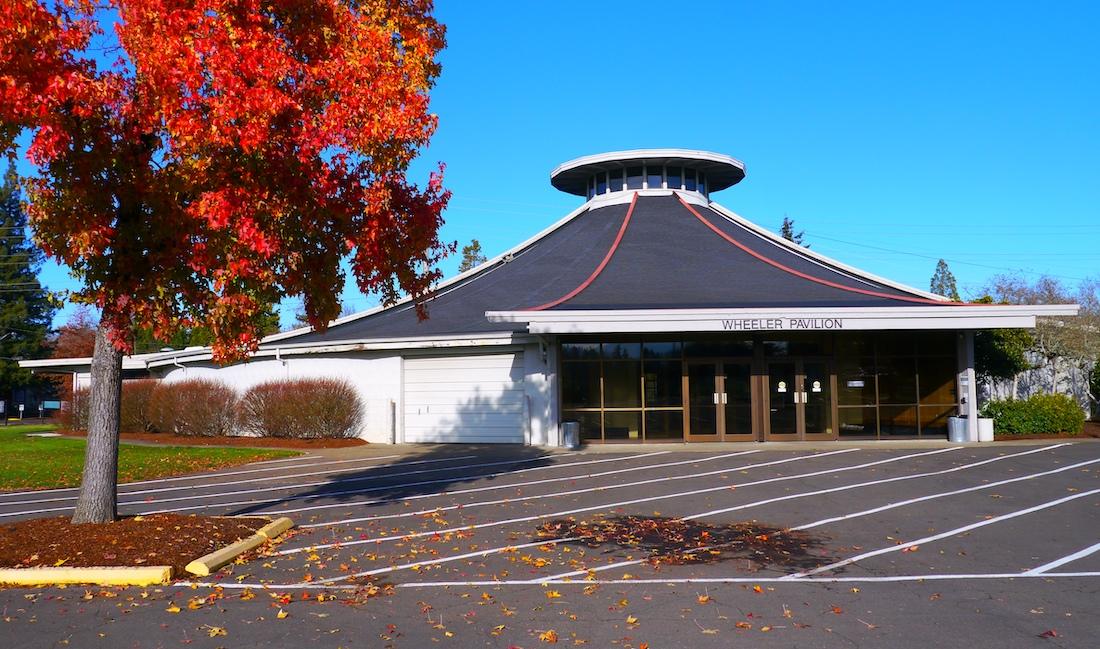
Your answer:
[149,378,238,437]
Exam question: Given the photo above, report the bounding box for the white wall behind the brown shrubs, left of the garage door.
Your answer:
[162,354,402,443]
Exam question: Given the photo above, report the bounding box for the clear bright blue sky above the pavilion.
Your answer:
[25,0,1100,330]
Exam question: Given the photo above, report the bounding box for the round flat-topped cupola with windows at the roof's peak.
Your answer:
[550,149,745,198]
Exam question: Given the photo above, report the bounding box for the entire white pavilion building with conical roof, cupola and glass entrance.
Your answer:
[22,150,1078,446]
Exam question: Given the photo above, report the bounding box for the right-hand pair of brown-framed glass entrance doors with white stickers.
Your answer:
[765,360,836,440]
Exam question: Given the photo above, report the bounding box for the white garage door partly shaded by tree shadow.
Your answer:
[404,353,526,443]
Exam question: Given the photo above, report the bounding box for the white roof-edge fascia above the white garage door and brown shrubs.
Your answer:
[149,332,535,367]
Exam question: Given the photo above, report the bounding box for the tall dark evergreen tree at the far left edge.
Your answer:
[0,160,54,413]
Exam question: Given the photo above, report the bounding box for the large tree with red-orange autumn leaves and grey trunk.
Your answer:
[0,0,449,520]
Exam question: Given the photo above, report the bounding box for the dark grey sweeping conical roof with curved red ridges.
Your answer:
[283,191,950,343]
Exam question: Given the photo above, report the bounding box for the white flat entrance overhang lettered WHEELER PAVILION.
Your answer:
[485,305,1080,333]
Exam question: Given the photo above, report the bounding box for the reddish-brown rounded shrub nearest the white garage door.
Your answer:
[241,378,363,439]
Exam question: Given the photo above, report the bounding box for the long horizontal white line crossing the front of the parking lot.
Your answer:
[184,572,1100,591]
